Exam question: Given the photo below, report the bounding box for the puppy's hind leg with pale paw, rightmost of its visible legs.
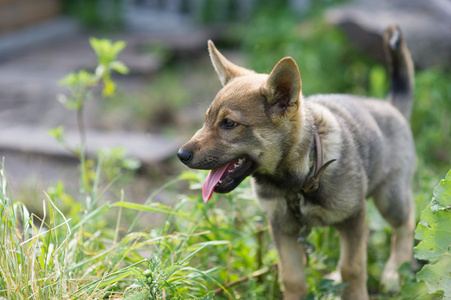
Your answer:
[374,184,415,292]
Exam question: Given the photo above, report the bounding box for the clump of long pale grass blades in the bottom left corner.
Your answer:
[0,158,129,299]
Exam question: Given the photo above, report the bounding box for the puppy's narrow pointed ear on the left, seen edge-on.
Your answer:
[208,40,254,86]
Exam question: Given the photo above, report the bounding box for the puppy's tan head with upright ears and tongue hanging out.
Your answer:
[177,41,302,202]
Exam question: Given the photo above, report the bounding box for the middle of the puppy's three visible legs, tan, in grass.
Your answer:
[335,200,369,300]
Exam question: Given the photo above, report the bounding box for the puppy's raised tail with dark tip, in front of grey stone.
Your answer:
[384,25,414,120]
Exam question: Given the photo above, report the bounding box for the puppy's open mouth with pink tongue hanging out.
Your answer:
[202,157,254,203]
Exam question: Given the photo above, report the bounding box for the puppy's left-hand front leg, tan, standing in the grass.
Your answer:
[270,220,307,300]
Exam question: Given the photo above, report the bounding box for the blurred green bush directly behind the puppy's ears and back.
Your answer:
[241,10,374,96]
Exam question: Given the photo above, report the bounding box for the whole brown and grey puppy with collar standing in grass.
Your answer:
[178,26,416,300]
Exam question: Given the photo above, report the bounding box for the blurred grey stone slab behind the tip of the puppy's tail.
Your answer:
[326,0,451,69]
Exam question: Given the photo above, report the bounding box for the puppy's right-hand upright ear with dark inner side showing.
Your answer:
[262,57,302,118]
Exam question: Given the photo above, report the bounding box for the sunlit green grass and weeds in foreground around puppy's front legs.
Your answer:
[0,162,354,299]
